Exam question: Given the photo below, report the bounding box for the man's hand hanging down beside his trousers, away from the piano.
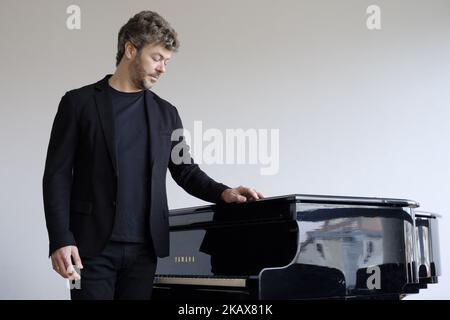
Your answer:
[51,246,83,280]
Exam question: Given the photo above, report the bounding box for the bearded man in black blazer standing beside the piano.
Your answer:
[43,11,263,299]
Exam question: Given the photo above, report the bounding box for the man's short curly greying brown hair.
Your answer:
[116,11,180,66]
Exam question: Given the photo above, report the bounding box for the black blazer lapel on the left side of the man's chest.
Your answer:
[95,75,119,176]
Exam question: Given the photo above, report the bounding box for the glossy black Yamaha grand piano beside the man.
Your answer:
[154,194,440,300]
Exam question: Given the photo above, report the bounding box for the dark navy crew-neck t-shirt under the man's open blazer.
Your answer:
[109,87,151,243]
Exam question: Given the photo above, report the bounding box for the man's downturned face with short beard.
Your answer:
[129,44,172,90]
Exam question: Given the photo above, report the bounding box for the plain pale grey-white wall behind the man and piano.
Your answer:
[0,0,450,299]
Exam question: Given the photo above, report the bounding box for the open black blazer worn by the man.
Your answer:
[43,75,228,257]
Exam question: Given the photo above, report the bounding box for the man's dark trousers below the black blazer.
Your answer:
[70,241,157,300]
